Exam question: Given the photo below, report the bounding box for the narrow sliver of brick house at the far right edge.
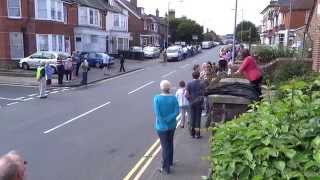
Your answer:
[309,0,320,72]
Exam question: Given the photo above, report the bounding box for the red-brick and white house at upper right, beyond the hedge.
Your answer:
[260,0,311,46]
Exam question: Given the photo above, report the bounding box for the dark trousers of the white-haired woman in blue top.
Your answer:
[158,129,175,173]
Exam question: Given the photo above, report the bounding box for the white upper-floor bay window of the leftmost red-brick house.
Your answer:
[34,0,64,22]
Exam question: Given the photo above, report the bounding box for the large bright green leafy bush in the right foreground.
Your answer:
[210,77,320,180]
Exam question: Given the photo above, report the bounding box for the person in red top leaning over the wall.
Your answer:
[236,49,263,96]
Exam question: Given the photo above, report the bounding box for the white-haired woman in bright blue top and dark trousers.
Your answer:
[154,80,179,174]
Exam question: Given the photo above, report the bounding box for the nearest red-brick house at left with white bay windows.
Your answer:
[0,0,77,65]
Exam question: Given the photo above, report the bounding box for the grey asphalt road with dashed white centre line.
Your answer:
[0,48,218,180]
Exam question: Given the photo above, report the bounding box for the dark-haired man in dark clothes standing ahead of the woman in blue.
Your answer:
[187,71,204,139]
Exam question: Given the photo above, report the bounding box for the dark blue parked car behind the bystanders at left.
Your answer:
[80,52,114,68]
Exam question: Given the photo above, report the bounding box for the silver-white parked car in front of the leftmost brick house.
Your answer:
[19,51,70,72]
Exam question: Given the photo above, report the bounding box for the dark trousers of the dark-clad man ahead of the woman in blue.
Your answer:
[190,102,203,136]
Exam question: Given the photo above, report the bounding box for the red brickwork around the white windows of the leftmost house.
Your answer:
[0,0,77,65]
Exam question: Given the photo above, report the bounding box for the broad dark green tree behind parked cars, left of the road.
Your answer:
[170,17,203,43]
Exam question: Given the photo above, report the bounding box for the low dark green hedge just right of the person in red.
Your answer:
[253,46,296,63]
